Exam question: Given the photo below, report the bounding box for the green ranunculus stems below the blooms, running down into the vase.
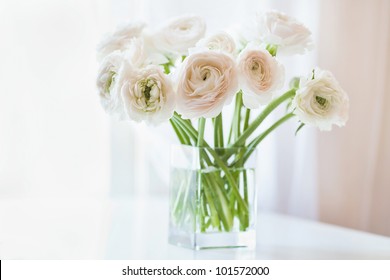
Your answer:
[170,88,296,232]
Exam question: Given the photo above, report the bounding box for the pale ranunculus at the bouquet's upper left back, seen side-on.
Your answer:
[97,23,145,60]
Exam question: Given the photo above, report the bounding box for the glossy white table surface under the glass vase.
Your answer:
[0,197,390,259]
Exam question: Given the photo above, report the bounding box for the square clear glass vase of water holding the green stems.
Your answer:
[169,145,257,250]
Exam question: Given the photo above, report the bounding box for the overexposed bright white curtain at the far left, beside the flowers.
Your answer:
[0,0,110,198]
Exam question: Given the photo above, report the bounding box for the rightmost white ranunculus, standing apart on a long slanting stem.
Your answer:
[292,68,349,130]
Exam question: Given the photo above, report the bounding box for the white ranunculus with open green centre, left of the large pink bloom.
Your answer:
[118,64,175,125]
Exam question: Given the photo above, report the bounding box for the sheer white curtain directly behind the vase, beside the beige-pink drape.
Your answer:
[112,0,318,218]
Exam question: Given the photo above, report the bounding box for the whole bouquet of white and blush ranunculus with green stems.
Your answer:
[97,11,348,248]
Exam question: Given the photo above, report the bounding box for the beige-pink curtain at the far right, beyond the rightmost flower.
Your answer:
[318,0,390,235]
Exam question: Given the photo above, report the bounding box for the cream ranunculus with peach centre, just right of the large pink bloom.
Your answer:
[238,45,284,109]
